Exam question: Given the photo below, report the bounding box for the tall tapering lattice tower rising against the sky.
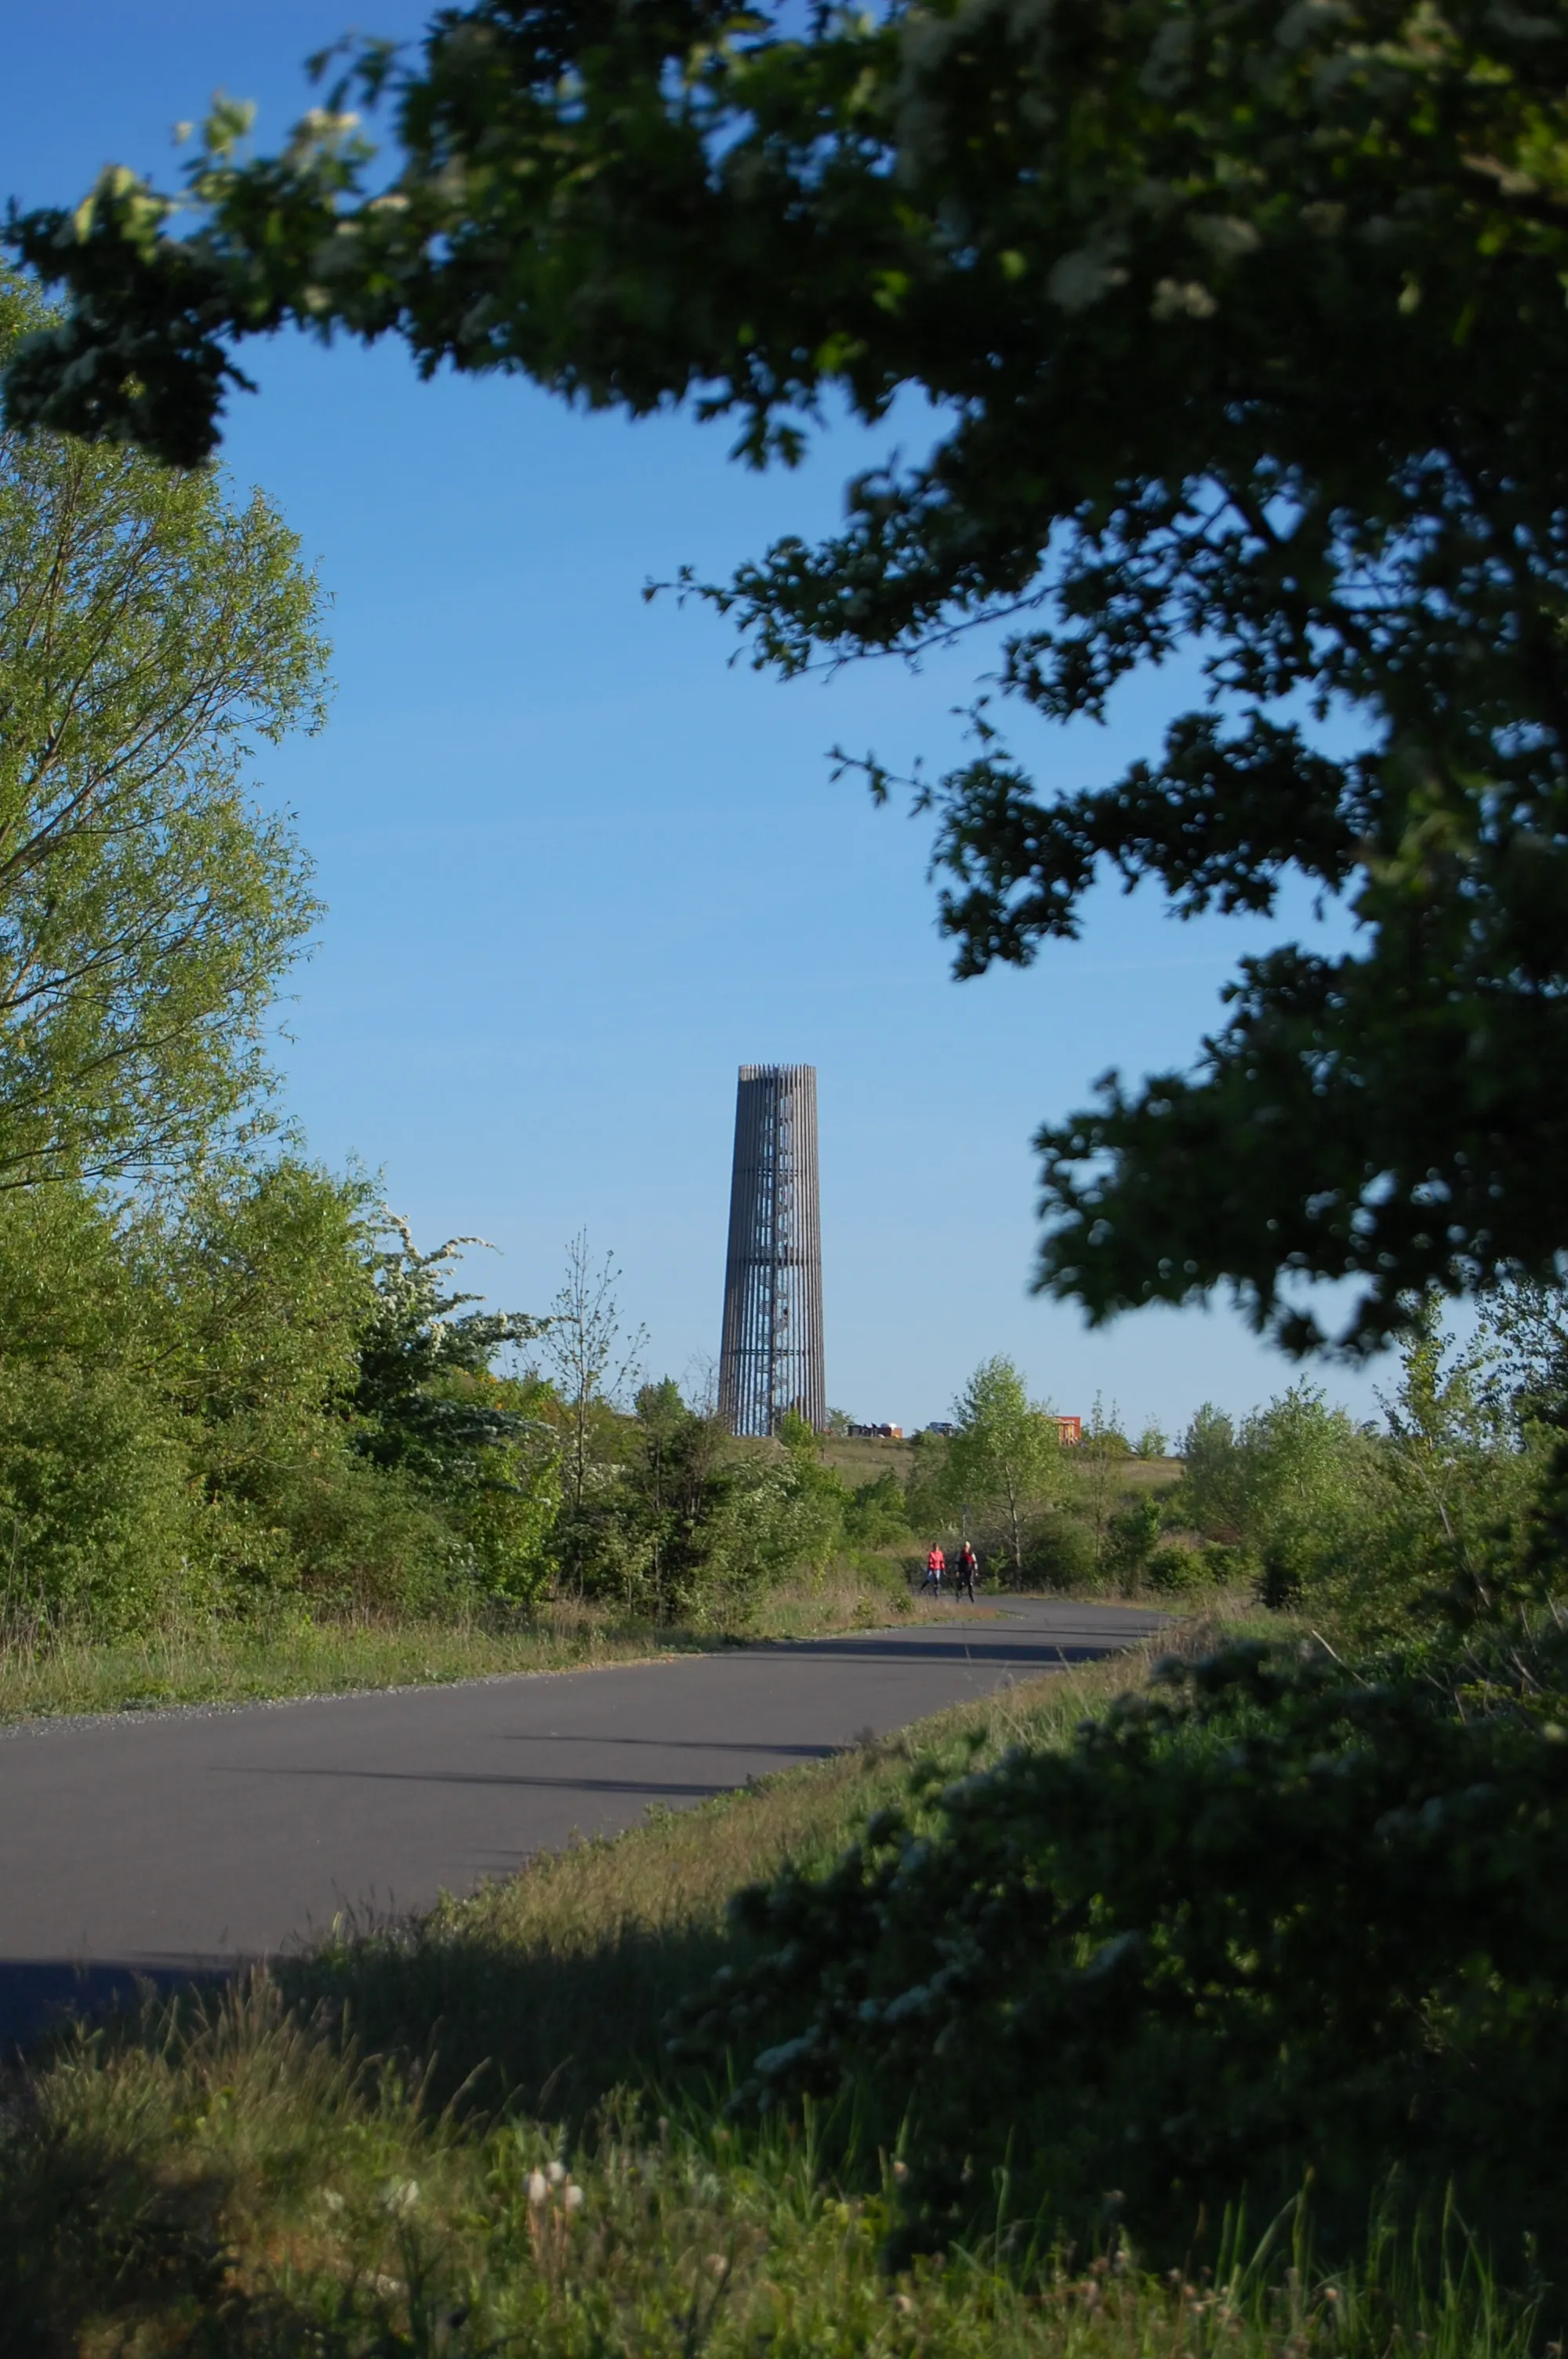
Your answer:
[719,1064,828,1434]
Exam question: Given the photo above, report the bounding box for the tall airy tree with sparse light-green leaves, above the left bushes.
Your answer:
[0,276,325,1187]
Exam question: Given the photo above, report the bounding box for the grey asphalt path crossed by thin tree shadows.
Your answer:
[0,1599,1160,2043]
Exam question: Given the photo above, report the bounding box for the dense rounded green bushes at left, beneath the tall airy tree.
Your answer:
[0,1174,559,1640]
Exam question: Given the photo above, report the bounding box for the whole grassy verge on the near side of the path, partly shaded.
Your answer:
[0,1628,1530,2359]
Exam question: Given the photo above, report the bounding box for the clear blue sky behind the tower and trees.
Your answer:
[0,0,1388,1430]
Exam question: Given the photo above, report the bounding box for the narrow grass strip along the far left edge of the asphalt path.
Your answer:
[0,1568,967,1722]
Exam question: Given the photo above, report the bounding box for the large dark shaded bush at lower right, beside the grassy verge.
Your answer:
[688,1647,1568,2265]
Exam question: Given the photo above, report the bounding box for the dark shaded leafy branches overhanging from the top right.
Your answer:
[7,0,1568,1350]
